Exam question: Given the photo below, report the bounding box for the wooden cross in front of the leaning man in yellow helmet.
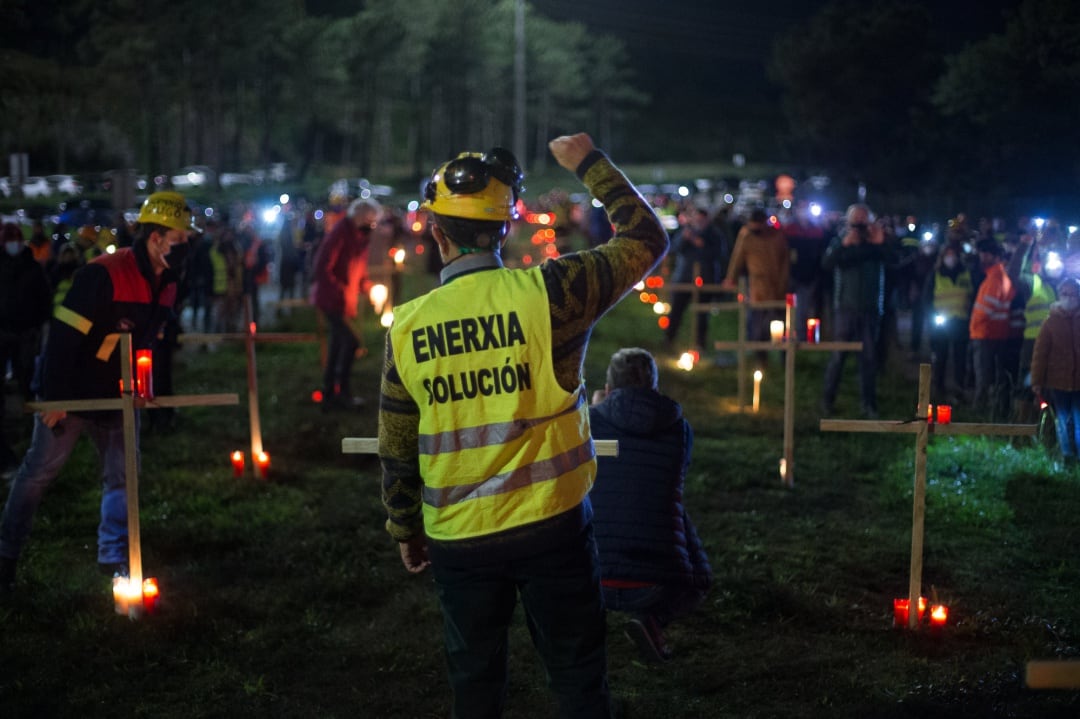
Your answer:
[26,333,240,600]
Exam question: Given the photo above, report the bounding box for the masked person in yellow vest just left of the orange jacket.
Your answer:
[927,245,974,401]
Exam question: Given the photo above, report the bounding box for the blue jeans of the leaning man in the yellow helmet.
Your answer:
[0,412,138,564]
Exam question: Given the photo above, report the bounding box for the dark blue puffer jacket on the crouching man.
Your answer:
[589,388,713,588]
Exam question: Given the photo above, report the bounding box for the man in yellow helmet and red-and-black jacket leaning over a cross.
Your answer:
[0,192,192,593]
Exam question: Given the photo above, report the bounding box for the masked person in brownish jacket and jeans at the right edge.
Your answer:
[1031,277,1080,469]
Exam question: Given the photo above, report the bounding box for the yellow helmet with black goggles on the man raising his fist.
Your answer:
[422,147,525,221]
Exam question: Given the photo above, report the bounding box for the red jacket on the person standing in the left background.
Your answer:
[311,217,372,317]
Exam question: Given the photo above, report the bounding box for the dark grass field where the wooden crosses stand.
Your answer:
[0,264,1080,719]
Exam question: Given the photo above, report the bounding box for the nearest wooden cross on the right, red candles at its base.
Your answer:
[821,365,1038,629]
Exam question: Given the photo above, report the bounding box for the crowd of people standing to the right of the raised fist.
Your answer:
[648,196,1080,431]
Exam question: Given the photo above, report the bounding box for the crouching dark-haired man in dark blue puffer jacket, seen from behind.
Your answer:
[589,348,713,662]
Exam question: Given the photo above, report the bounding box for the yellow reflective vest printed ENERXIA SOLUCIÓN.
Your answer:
[390,268,596,541]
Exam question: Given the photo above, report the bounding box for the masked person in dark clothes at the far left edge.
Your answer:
[0,222,51,477]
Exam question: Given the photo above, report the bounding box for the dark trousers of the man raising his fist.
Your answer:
[431,526,609,719]
